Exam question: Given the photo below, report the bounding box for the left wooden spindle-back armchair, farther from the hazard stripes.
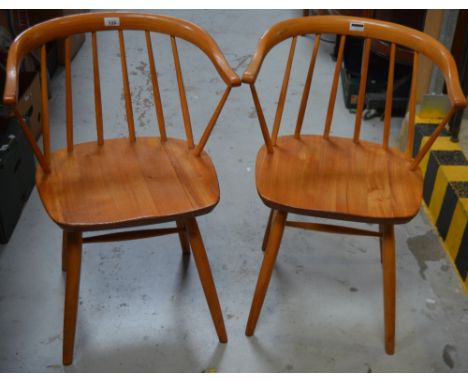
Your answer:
[3,13,240,365]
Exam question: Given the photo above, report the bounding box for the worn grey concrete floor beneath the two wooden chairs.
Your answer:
[0,11,468,372]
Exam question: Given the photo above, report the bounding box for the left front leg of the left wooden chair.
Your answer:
[63,232,82,365]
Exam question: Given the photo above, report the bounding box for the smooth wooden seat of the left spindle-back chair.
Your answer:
[36,137,219,230]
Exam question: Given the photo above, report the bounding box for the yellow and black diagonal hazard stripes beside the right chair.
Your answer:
[413,124,468,291]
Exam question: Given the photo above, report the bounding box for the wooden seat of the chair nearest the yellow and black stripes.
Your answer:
[256,135,423,224]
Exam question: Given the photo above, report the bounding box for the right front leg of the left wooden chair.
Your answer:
[185,218,227,343]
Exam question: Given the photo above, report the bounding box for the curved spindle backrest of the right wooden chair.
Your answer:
[242,16,466,169]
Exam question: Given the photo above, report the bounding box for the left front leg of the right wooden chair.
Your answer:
[245,211,288,336]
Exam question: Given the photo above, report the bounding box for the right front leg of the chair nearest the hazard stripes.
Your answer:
[382,224,396,354]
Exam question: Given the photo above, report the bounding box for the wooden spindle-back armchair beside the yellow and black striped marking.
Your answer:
[242,16,466,354]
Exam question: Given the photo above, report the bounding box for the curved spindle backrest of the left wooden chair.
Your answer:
[3,12,241,172]
